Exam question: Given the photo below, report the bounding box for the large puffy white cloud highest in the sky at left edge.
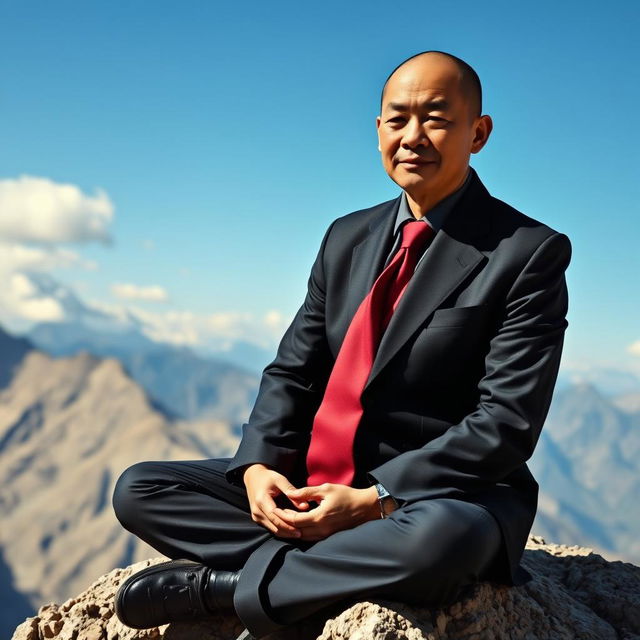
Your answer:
[0,175,113,244]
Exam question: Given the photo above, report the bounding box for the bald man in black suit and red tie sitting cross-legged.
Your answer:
[114,51,570,638]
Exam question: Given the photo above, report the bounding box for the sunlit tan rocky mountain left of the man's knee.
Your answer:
[0,347,237,627]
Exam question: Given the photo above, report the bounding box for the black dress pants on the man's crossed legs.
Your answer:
[113,458,502,638]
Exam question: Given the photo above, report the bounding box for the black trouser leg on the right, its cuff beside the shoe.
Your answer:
[234,499,501,637]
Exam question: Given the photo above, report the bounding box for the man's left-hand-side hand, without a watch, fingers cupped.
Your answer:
[242,464,309,538]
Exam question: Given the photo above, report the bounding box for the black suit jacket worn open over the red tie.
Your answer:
[227,172,571,584]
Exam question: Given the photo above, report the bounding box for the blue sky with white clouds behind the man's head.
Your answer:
[0,0,640,370]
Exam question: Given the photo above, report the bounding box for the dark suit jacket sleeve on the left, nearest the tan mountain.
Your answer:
[226,223,334,486]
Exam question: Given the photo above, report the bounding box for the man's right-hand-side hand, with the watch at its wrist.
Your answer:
[273,482,380,541]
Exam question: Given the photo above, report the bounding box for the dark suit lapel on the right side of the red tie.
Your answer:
[365,170,489,389]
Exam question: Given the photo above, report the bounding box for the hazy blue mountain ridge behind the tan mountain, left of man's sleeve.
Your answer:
[28,322,258,425]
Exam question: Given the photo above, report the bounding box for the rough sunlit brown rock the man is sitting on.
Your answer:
[13,536,640,640]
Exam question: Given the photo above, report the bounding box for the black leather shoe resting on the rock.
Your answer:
[115,560,221,629]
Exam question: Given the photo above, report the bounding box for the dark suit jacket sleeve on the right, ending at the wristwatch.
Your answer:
[368,234,571,504]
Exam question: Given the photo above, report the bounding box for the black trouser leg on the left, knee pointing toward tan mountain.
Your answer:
[113,458,273,570]
